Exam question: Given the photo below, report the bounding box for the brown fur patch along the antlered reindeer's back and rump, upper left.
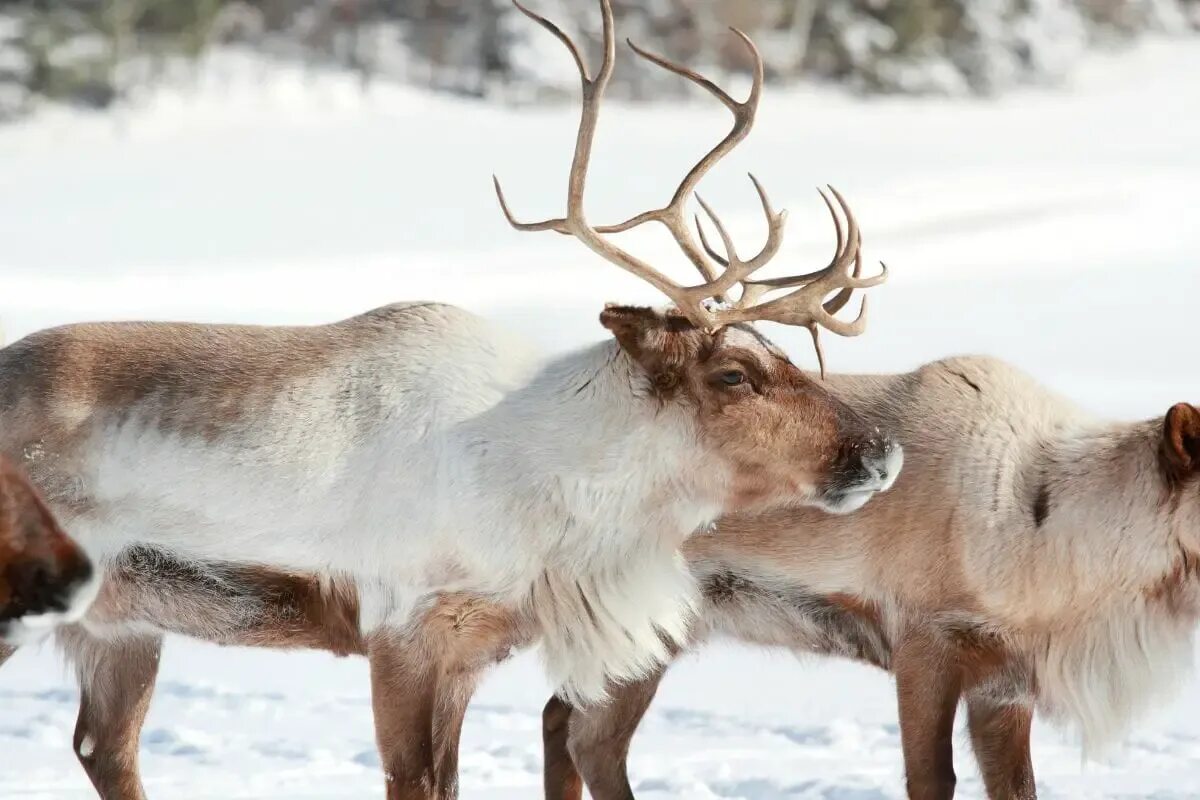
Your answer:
[0,305,448,455]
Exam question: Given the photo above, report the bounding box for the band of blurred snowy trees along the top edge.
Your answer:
[0,0,1200,119]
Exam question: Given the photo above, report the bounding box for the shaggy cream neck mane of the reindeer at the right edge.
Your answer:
[1025,421,1200,753]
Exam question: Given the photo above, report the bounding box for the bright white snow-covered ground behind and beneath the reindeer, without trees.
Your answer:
[0,42,1200,800]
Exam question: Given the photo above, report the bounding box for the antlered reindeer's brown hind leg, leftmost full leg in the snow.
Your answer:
[60,627,162,800]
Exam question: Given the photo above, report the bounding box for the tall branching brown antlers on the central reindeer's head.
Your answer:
[493,0,887,372]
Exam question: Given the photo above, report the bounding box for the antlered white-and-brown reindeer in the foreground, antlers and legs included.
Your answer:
[0,0,902,798]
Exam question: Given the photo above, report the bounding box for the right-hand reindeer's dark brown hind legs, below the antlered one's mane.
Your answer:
[559,668,666,800]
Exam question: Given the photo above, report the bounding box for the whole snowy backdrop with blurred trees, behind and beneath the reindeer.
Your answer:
[0,0,1200,800]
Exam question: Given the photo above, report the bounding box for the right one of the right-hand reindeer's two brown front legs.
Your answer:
[967,694,1038,800]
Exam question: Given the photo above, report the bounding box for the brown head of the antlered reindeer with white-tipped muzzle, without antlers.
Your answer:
[600,306,904,513]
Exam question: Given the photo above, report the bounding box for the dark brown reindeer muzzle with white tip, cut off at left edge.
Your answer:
[0,456,95,652]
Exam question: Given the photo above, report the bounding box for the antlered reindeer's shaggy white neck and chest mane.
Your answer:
[463,342,727,702]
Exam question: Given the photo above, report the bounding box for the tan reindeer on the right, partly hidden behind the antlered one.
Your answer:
[544,357,1200,800]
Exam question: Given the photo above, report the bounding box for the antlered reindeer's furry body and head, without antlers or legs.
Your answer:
[0,303,899,699]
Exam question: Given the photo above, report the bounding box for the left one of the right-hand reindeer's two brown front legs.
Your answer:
[892,632,962,800]
